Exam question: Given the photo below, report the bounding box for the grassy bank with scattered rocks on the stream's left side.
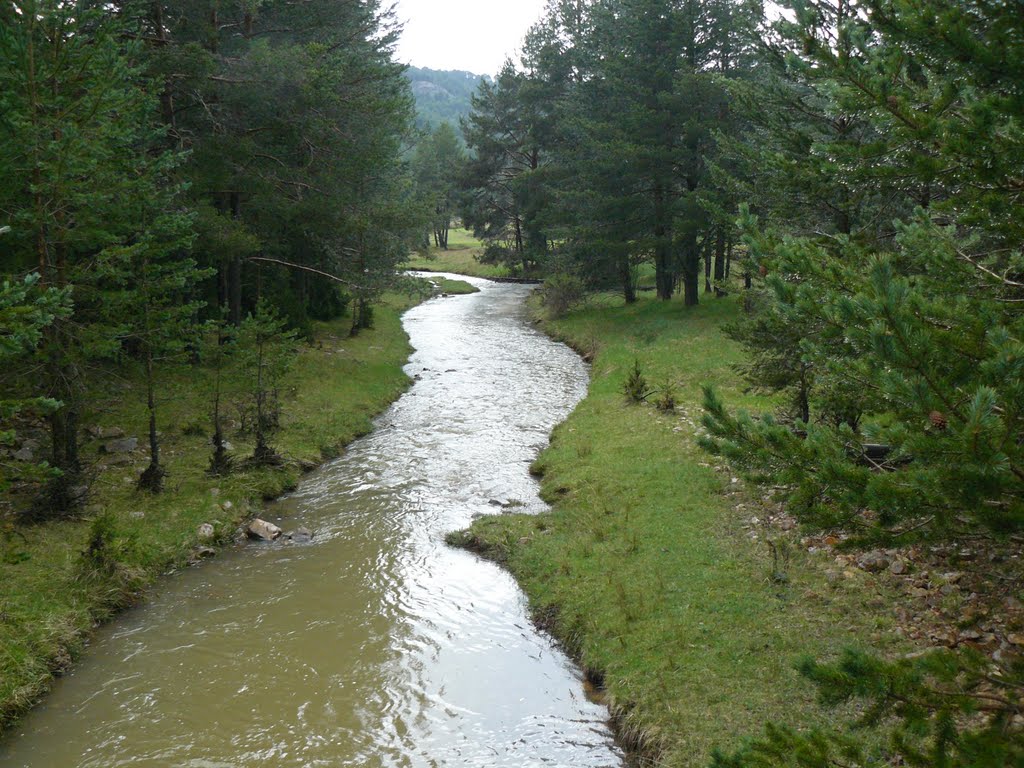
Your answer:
[0,284,469,727]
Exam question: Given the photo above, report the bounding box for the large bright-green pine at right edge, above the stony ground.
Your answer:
[707,3,1024,541]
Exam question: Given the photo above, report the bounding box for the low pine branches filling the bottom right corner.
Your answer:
[712,649,1024,768]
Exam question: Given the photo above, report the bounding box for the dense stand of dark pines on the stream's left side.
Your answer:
[0,0,426,505]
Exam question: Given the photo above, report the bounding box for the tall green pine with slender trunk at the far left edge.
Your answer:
[0,0,192,518]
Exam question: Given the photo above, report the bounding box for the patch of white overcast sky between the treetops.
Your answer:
[395,0,546,75]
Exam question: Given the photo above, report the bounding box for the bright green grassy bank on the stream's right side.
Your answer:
[452,296,900,766]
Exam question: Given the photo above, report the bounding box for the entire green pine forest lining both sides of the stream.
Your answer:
[0,0,1024,768]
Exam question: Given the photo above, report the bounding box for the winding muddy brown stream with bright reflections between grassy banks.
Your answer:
[0,281,622,768]
